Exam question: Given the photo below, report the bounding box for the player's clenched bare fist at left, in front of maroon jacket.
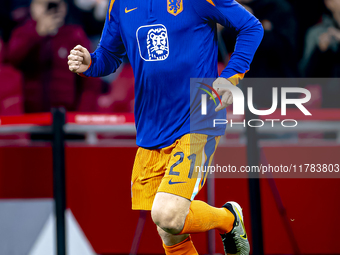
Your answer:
[67,45,91,73]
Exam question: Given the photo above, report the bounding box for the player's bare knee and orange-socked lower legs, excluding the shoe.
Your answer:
[151,192,234,255]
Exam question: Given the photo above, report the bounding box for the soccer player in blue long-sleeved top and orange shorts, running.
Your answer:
[68,0,263,252]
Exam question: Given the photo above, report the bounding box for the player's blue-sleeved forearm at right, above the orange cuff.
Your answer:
[221,17,263,78]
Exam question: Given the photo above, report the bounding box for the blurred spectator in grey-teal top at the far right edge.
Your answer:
[300,0,340,77]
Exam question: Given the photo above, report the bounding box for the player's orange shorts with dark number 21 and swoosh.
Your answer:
[131,134,220,210]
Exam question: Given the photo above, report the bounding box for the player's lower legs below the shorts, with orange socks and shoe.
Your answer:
[151,193,249,255]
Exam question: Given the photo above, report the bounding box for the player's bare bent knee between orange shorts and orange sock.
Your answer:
[151,205,185,234]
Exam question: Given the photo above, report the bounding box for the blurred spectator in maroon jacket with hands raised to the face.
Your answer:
[7,0,101,113]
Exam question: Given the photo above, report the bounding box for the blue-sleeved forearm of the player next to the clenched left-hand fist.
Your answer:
[83,46,124,77]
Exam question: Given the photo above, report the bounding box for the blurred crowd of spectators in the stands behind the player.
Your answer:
[0,0,340,115]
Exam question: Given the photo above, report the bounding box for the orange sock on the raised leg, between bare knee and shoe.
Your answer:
[179,200,235,235]
